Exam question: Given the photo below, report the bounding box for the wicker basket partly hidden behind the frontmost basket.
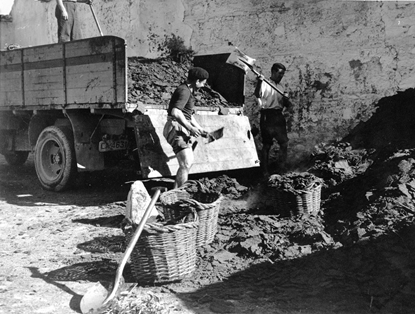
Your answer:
[160,188,222,247]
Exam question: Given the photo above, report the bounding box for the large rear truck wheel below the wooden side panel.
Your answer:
[34,126,77,192]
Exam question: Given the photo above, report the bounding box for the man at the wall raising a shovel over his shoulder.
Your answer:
[254,63,290,176]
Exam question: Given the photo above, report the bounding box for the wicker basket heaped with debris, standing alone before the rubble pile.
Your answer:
[273,181,322,216]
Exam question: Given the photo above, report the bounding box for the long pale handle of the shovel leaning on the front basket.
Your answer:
[102,187,166,305]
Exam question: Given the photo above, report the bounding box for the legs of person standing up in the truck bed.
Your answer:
[55,0,93,43]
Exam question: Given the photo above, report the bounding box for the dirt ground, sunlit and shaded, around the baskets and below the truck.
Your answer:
[0,144,415,314]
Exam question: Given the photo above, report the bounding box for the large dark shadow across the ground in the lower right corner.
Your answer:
[173,226,415,314]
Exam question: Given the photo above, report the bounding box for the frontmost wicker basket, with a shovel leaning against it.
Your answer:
[126,215,199,283]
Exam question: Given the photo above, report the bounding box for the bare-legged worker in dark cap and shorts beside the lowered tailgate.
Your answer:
[163,67,209,188]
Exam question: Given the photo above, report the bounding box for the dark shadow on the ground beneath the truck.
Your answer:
[0,156,136,207]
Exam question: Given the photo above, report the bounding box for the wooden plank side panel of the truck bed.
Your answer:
[0,36,127,110]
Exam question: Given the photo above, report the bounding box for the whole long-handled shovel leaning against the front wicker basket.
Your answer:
[80,187,167,314]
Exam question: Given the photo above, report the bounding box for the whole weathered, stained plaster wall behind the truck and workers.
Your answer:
[0,0,415,164]
